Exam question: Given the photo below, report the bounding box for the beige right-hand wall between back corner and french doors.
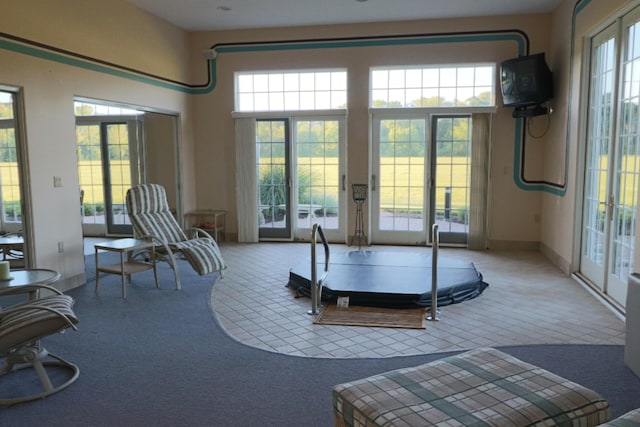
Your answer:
[540,0,639,273]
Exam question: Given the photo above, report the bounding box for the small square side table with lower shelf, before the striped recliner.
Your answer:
[95,238,159,299]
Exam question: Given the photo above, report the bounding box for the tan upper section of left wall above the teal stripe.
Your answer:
[0,0,190,81]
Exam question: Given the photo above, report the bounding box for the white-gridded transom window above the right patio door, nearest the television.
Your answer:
[370,65,496,108]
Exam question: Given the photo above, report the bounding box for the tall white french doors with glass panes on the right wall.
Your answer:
[580,10,640,307]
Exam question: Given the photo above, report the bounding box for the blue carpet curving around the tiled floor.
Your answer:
[0,257,640,427]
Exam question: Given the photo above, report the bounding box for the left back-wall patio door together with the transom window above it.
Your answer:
[234,69,347,241]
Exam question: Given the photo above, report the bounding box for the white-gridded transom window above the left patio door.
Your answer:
[235,70,347,112]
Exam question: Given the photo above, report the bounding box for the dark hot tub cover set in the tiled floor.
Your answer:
[287,250,489,308]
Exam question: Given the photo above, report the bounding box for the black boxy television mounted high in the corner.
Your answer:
[500,53,553,107]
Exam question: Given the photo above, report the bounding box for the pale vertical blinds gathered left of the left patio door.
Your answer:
[235,118,258,243]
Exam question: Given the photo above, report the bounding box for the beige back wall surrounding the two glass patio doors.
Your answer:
[192,15,551,244]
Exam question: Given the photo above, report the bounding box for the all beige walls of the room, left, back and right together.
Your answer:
[0,0,628,288]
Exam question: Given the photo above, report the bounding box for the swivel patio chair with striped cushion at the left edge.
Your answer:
[0,285,80,405]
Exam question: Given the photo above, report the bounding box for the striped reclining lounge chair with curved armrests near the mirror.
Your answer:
[127,184,227,289]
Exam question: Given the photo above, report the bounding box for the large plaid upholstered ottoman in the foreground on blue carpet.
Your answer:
[333,348,610,427]
